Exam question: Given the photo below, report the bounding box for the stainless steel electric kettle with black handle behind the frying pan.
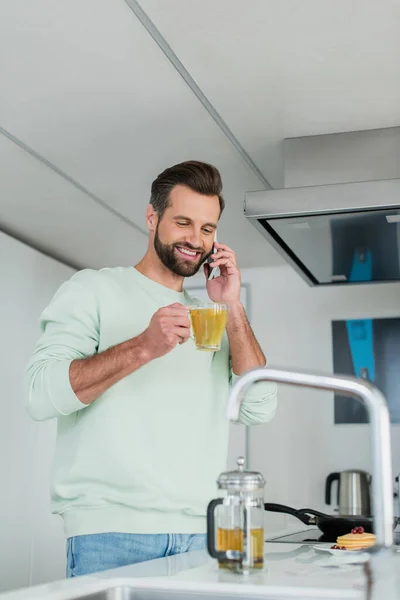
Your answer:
[325,470,371,517]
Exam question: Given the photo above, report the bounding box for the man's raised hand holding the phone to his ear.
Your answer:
[204,242,240,305]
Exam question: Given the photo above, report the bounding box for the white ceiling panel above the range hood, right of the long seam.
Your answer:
[139,0,400,187]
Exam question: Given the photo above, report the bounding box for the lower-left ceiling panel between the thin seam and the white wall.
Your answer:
[0,136,147,268]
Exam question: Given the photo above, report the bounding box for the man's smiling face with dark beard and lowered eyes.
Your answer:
[154,185,220,277]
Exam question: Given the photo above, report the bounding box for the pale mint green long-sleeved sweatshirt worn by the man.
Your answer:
[27,267,276,537]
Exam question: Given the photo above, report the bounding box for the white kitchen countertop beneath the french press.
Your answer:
[0,542,400,600]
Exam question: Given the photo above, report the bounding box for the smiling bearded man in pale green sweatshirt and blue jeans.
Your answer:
[27,161,276,577]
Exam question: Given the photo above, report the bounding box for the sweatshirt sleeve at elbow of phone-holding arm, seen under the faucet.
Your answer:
[230,358,278,425]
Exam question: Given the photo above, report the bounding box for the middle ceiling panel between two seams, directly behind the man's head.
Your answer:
[0,0,281,266]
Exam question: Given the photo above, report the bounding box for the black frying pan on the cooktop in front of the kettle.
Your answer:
[264,502,398,542]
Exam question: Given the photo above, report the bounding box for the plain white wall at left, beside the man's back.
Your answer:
[0,233,73,592]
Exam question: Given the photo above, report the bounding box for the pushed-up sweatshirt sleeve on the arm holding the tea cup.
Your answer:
[26,269,99,421]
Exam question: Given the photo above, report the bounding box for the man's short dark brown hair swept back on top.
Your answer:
[150,160,225,218]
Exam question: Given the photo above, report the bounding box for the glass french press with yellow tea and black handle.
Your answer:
[207,456,265,573]
